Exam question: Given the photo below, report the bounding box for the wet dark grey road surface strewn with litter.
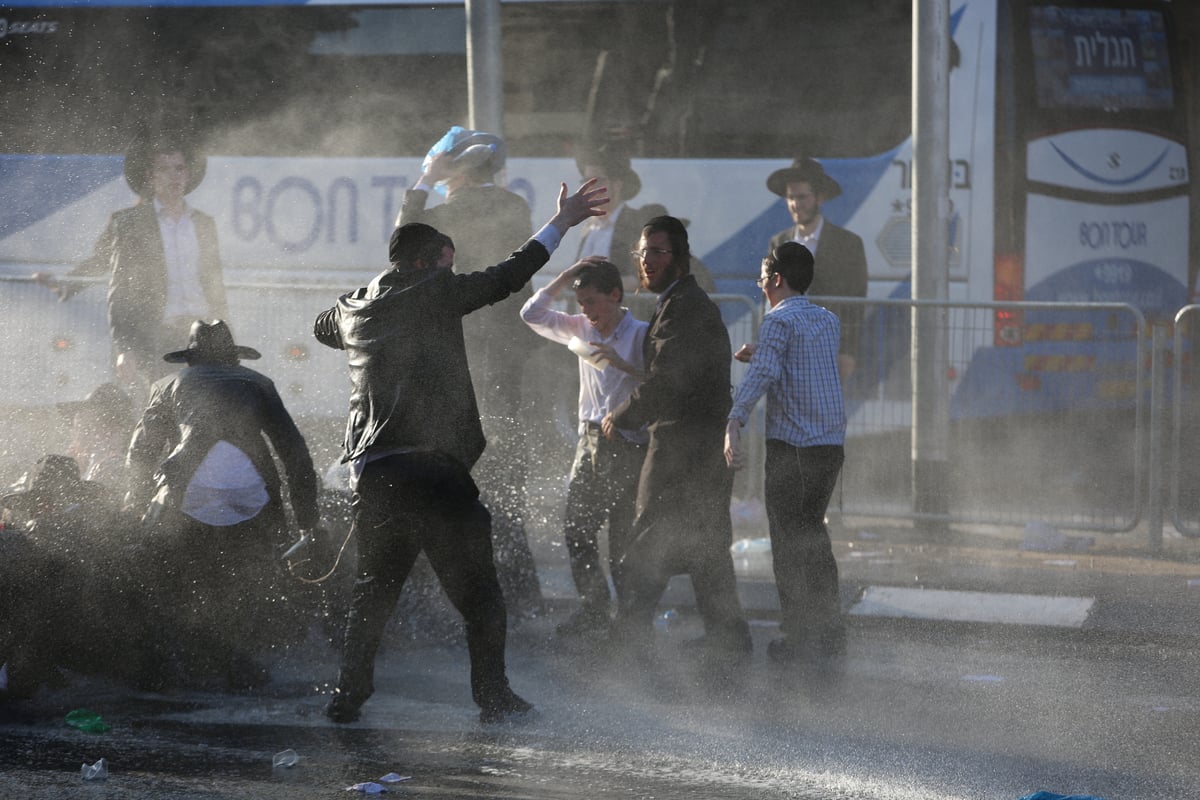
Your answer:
[0,510,1200,800]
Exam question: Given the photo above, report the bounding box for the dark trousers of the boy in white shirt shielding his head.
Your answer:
[563,423,646,609]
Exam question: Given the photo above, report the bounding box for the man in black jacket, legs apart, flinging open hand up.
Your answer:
[313,181,607,723]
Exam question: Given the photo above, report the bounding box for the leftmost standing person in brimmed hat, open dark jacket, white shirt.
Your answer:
[35,132,226,393]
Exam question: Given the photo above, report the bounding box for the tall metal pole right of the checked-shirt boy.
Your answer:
[912,0,950,528]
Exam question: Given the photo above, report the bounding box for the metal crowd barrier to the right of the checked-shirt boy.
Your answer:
[814,297,1151,531]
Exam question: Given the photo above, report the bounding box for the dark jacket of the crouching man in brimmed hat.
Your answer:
[128,363,318,529]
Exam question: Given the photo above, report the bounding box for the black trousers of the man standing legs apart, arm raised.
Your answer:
[337,452,510,708]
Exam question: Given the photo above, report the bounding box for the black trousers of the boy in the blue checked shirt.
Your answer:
[766,439,845,640]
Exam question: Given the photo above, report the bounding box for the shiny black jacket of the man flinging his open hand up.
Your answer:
[313,240,550,468]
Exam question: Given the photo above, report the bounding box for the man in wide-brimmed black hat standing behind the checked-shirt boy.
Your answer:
[767,158,866,380]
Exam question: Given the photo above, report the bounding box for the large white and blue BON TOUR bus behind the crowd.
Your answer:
[0,0,1196,432]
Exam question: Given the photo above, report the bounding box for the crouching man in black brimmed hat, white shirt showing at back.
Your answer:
[128,320,318,688]
